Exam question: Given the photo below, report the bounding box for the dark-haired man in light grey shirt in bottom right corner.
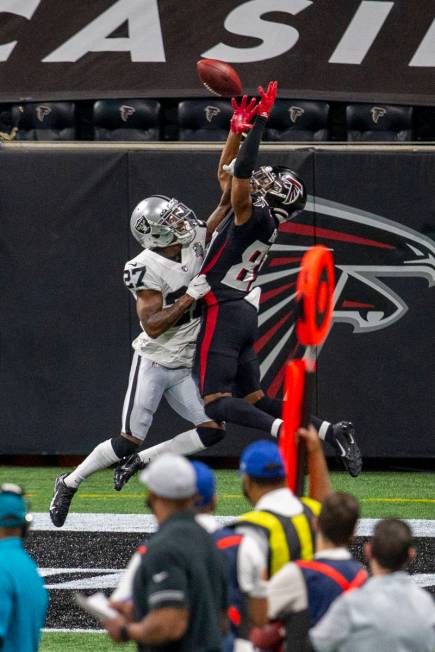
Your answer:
[310,518,435,652]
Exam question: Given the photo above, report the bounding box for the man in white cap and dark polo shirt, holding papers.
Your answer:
[105,453,227,652]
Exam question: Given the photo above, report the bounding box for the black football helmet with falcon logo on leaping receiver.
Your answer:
[251,165,307,222]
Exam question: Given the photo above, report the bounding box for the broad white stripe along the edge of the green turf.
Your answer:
[32,512,435,537]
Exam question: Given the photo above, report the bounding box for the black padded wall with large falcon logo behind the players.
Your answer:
[0,146,435,457]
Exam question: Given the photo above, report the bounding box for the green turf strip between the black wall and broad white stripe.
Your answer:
[0,466,435,519]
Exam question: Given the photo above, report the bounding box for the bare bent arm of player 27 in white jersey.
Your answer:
[136,290,194,338]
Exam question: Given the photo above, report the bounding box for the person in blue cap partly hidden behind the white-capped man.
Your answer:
[192,462,267,652]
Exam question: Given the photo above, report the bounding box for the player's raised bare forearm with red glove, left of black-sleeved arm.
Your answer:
[218,95,257,191]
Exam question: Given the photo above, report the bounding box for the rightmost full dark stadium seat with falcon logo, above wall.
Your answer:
[346,104,413,141]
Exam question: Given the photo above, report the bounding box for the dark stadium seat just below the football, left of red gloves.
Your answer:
[178,98,233,141]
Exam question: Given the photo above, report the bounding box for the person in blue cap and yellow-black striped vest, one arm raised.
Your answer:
[237,426,332,578]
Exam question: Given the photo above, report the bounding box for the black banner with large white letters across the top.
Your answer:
[0,0,435,105]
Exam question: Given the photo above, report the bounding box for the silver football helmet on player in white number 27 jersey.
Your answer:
[130,195,197,249]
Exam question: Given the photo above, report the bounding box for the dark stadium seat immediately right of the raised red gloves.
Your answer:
[264,100,330,142]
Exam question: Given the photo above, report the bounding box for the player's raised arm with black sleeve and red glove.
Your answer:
[231,82,278,225]
